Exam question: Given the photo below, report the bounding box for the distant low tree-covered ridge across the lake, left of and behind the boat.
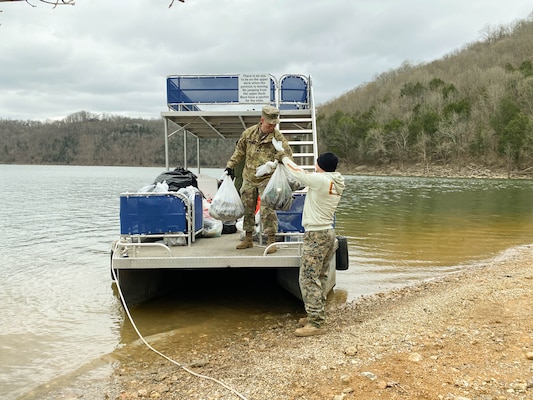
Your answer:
[0,111,235,167]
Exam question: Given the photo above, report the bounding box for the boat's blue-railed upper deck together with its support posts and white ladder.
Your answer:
[161,74,318,172]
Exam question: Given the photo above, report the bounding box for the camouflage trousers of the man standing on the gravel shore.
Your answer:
[300,229,335,327]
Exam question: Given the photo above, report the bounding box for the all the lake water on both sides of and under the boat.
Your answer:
[0,165,533,400]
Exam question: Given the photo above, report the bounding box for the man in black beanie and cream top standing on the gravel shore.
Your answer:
[276,151,345,336]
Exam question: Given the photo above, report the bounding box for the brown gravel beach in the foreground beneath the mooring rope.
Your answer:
[33,245,533,400]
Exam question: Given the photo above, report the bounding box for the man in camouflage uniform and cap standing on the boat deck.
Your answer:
[226,106,292,253]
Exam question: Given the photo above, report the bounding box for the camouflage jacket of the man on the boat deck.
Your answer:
[226,123,292,185]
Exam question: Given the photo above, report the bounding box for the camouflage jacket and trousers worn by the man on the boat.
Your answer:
[226,123,292,235]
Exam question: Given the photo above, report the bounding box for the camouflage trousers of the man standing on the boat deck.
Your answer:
[241,179,278,235]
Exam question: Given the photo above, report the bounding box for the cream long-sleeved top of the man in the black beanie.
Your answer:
[283,156,345,231]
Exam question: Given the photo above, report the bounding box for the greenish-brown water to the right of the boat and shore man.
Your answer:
[337,177,533,298]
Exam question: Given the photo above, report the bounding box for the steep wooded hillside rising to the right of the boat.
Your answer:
[318,13,533,175]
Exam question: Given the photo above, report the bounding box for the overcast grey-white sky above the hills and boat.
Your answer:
[0,0,533,120]
